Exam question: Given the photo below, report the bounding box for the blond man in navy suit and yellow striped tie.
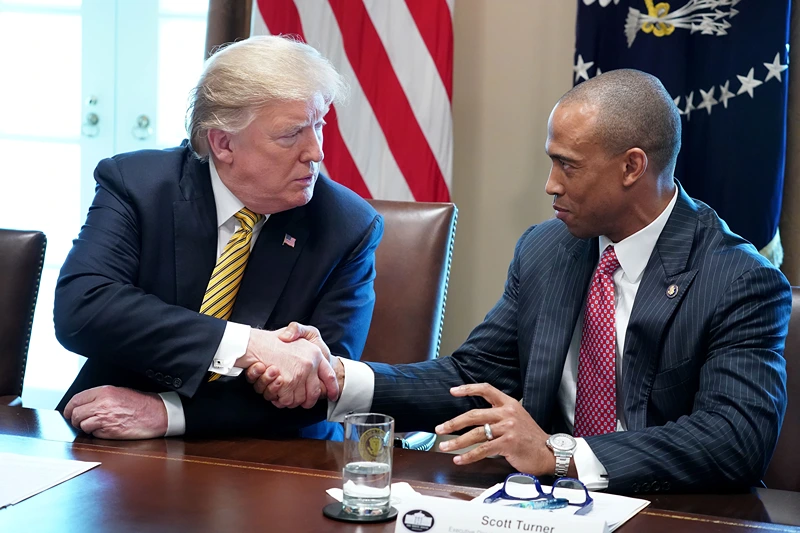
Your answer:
[55,36,383,439]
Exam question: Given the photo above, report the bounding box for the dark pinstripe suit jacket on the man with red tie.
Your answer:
[370,186,791,493]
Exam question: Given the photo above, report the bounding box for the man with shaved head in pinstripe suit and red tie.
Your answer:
[266,70,791,493]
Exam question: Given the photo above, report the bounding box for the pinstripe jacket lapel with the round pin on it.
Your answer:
[621,185,697,430]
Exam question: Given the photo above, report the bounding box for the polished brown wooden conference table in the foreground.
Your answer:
[0,406,800,533]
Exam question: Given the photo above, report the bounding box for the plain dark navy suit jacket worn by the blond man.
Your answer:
[54,143,383,438]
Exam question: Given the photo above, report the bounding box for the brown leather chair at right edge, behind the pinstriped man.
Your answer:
[764,287,800,491]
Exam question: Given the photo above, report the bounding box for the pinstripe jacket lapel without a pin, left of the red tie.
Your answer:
[523,237,598,426]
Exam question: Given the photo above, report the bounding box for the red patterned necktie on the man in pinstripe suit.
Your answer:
[574,246,619,437]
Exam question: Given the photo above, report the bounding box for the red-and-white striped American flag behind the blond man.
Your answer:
[252,0,455,202]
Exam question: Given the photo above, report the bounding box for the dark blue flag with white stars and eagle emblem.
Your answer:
[573,0,791,265]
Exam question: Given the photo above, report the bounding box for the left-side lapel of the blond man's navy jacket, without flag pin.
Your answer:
[173,156,217,310]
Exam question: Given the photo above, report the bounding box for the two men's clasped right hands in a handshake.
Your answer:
[241,322,344,409]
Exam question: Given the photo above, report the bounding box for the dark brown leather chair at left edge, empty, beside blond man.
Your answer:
[0,229,47,405]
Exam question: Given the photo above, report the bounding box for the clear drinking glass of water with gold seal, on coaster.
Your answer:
[342,413,394,516]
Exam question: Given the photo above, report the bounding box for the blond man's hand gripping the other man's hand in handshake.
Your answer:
[236,329,339,409]
